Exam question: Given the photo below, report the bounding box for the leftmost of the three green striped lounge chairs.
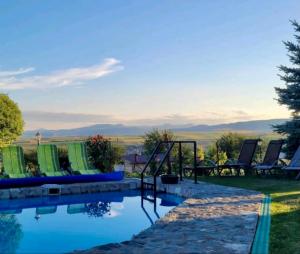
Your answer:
[2,146,31,178]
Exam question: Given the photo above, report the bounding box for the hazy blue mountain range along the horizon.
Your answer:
[23,119,287,138]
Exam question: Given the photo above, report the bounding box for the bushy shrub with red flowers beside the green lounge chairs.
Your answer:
[87,135,124,171]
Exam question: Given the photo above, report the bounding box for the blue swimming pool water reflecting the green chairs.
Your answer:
[0,190,183,254]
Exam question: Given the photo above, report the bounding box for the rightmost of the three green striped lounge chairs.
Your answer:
[68,142,100,175]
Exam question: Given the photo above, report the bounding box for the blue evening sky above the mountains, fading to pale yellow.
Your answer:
[0,0,300,129]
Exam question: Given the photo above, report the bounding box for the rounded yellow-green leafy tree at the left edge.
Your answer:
[0,94,24,148]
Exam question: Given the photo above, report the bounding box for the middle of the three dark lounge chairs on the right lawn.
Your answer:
[254,139,284,175]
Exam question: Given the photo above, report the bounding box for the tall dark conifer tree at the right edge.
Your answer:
[274,21,300,158]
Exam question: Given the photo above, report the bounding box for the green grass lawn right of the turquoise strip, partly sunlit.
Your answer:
[199,177,300,254]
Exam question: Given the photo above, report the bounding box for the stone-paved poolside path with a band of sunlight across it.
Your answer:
[75,180,263,254]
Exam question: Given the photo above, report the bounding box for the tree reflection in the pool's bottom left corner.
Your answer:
[0,214,23,254]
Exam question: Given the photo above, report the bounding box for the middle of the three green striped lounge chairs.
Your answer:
[37,144,68,176]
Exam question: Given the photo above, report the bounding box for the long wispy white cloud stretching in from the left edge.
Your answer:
[0,58,123,90]
